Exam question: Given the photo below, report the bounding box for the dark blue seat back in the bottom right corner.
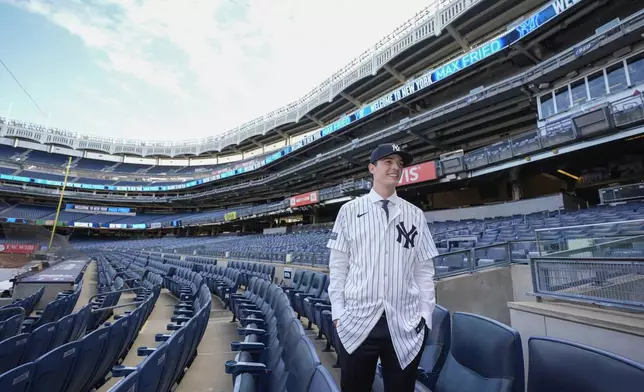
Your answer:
[527,337,644,392]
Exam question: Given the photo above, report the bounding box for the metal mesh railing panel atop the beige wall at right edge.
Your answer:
[530,235,644,311]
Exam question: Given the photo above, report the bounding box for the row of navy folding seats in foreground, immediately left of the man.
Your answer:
[225,277,339,392]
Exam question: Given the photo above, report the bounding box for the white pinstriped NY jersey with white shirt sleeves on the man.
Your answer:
[327,189,438,369]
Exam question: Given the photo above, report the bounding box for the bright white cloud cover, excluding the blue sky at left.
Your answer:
[3,0,426,139]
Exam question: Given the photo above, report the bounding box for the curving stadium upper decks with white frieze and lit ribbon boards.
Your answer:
[0,0,644,233]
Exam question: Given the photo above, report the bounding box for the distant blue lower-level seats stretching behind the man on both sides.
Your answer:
[73,202,644,267]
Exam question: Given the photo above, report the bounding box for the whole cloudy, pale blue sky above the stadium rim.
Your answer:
[0,0,432,141]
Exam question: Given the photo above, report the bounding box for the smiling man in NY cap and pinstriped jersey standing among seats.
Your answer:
[327,144,438,392]
